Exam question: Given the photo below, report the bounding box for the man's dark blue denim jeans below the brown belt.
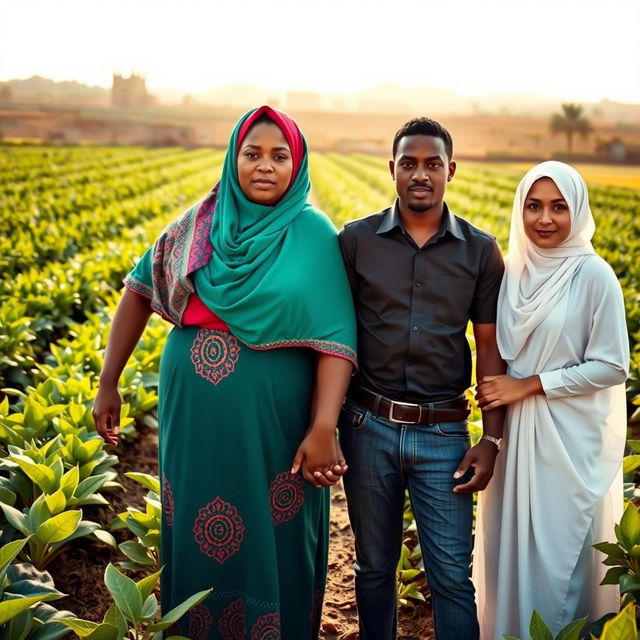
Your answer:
[339,400,479,640]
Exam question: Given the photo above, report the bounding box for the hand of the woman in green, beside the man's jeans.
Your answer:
[291,426,347,487]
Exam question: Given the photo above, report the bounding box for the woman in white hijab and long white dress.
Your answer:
[473,162,629,640]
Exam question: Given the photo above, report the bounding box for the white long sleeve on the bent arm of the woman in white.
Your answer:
[540,264,629,398]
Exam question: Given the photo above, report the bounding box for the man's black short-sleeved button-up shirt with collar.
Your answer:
[340,202,504,402]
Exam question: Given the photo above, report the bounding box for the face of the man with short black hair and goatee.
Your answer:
[389,135,456,213]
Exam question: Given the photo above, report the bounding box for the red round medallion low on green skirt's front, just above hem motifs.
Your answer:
[193,496,245,564]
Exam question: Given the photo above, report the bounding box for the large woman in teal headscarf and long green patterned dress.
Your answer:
[94,107,355,640]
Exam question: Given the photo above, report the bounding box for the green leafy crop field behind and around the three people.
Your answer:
[0,146,640,640]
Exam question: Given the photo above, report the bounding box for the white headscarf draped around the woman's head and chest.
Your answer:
[497,160,595,369]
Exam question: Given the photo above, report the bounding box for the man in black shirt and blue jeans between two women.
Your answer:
[340,118,505,640]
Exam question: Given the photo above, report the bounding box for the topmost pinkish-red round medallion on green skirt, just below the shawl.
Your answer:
[191,329,240,384]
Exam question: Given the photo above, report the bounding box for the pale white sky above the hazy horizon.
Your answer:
[0,0,640,103]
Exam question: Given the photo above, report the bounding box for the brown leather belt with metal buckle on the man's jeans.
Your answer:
[347,387,470,424]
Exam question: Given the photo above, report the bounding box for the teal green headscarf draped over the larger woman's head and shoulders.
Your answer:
[125,107,356,362]
